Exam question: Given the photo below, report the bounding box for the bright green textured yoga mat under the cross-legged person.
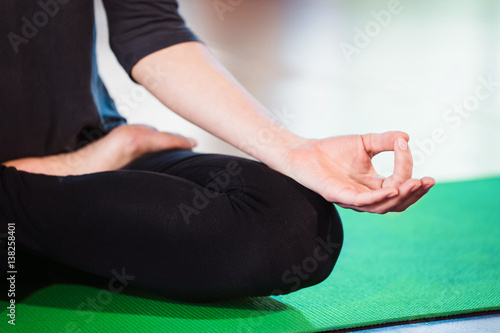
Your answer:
[0,178,500,333]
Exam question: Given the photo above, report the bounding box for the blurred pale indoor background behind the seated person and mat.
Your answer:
[96,0,500,181]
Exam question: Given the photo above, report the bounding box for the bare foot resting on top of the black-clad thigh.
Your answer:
[2,125,196,176]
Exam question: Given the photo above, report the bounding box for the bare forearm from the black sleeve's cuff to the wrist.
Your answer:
[132,42,302,169]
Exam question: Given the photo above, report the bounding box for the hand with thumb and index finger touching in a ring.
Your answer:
[282,132,435,214]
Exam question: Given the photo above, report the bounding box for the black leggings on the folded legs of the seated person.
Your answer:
[0,150,343,301]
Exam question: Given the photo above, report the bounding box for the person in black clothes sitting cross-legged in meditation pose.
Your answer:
[0,0,434,301]
